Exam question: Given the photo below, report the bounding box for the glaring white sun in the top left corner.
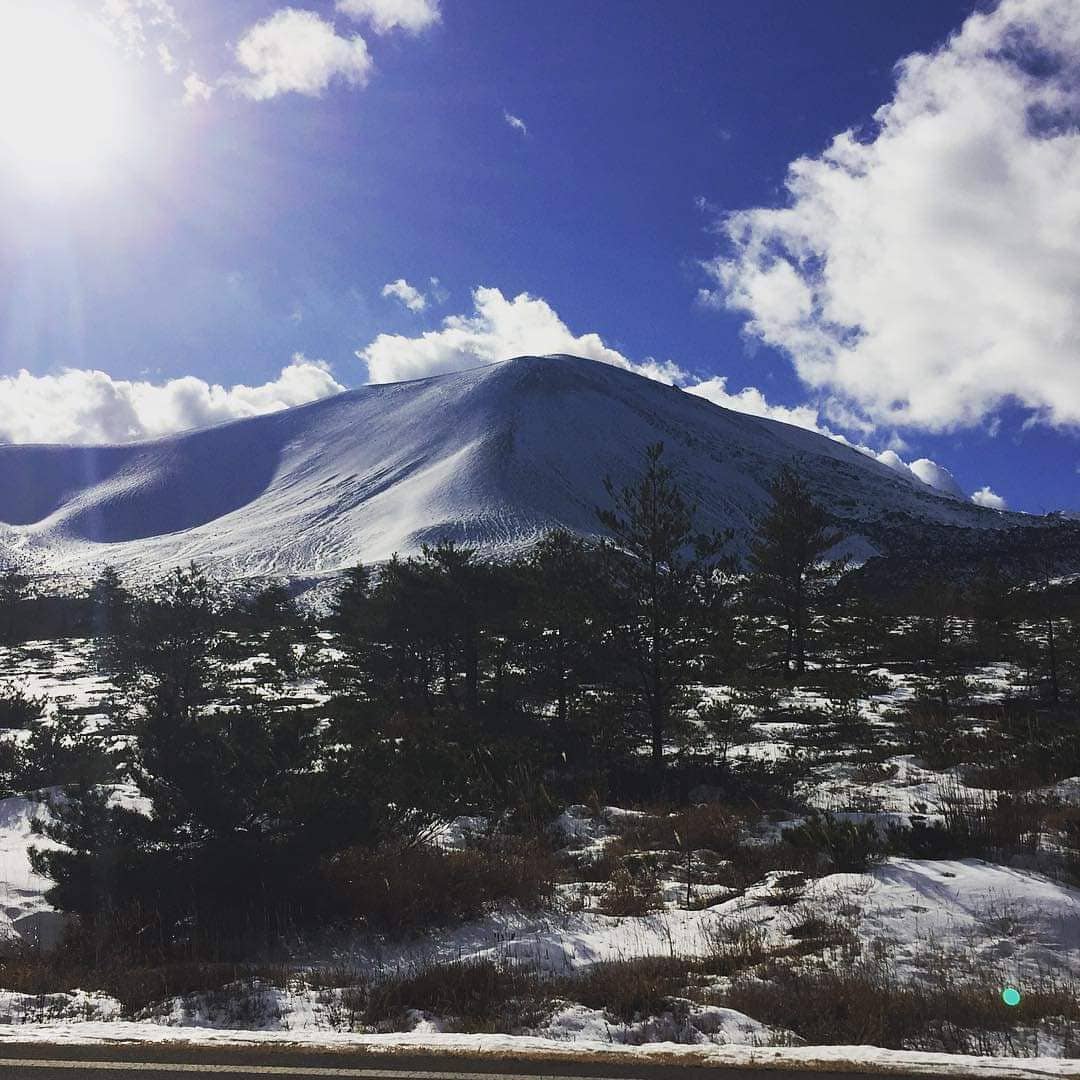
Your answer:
[0,0,126,191]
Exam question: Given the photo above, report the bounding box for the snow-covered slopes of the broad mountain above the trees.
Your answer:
[0,356,1024,576]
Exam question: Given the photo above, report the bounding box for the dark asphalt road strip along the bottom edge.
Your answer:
[0,1042,959,1080]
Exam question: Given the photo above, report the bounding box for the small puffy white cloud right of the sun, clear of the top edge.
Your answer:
[229,8,373,102]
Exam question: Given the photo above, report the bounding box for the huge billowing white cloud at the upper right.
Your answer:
[700,0,1080,431]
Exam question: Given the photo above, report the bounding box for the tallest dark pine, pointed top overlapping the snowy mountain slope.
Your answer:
[597,443,728,769]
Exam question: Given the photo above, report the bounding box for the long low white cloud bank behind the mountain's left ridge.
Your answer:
[0,353,345,445]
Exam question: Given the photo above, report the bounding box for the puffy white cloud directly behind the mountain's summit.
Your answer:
[356,287,683,382]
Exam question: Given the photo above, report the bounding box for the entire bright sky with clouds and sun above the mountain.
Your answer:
[0,0,1080,512]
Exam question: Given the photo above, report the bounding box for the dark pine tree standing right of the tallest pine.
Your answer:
[750,465,843,675]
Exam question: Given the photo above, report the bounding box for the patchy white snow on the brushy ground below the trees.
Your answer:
[0,642,1080,1058]
